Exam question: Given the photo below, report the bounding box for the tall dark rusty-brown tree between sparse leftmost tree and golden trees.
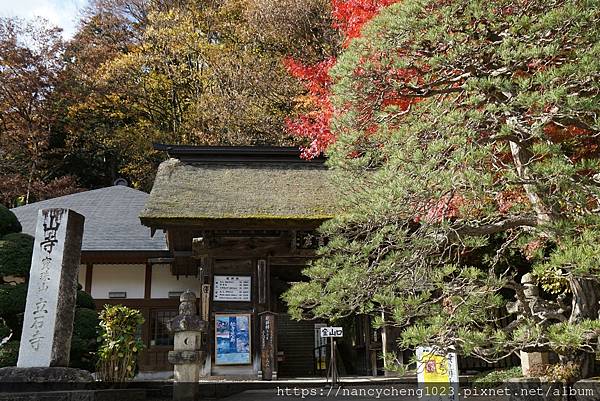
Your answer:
[47,0,147,188]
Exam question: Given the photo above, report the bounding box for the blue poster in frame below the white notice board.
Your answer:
[215,315,251,365]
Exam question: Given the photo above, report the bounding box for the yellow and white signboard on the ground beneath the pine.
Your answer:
[417,347,458,401]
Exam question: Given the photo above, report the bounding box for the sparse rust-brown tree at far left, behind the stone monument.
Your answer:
[0,18,77,206]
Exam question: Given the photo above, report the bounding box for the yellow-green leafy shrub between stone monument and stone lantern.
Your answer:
[97,305,144,382]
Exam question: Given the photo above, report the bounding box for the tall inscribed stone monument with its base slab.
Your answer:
[0,209,91,382]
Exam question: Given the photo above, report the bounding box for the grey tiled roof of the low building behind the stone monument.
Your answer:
[12,185,167,251]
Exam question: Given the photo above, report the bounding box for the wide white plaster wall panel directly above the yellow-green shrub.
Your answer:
[92,265,146,299]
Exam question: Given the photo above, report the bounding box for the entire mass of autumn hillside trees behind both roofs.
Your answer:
[0,0,339,197]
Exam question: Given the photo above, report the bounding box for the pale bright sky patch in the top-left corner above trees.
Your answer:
[0,0,88,39]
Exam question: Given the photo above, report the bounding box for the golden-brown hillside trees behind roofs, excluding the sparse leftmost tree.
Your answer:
[65,0,333,188]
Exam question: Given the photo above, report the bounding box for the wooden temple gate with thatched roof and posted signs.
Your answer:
[140,145,344,378]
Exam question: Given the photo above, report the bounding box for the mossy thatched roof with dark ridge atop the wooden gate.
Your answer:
[140,147,335,227]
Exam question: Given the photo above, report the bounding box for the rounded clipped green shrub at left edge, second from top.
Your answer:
[0,233,34,278]
